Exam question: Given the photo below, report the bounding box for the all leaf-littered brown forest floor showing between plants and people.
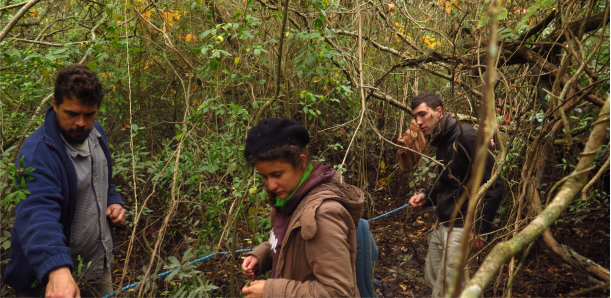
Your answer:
[107,187,610,298]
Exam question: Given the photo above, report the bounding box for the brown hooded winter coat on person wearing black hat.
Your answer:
[251,174,364,298]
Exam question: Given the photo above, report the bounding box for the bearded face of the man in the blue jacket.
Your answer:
[53,97,98,144]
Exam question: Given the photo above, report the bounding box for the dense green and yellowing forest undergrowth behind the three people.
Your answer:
[0,0,609,297]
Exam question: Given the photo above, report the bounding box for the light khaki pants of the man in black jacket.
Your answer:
[424,224,469,298]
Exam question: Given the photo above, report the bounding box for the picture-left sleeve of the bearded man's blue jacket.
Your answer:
[13,145,74,283]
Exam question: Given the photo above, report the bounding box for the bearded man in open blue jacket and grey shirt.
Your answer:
[3,65,125,298]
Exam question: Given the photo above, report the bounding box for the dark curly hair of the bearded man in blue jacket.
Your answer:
[53,64,104,108]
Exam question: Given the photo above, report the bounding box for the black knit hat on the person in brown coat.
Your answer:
[244,117,310,160]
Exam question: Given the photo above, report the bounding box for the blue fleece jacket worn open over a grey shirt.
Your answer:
[3,107,123,297]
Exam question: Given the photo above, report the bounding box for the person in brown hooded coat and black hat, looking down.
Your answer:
[242,117,364,298]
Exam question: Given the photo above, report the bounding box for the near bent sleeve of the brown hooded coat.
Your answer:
[263,202,358,298]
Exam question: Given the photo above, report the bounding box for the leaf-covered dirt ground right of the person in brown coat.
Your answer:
[371,197,609,298]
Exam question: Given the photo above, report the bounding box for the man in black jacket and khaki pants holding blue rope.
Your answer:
[410,93,504,297]
